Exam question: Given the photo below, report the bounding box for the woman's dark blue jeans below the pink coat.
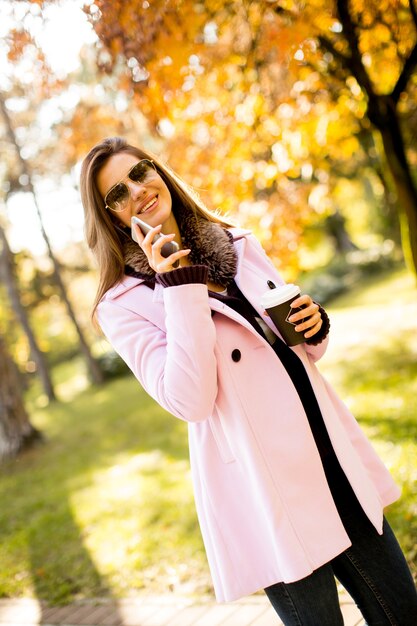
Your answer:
[265,506,417,626]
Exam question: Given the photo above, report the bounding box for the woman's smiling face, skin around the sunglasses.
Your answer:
[97,152,173,232]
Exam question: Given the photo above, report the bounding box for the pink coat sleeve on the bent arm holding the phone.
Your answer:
[97,284,217,422]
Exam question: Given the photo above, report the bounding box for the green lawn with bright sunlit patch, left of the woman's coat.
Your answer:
[0,372,210,602]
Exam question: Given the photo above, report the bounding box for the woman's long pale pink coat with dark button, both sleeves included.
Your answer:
[98,228,400,602]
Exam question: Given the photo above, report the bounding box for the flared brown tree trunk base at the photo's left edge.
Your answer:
[0,337,43,460]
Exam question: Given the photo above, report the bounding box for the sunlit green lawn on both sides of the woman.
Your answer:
[0,271,417,603]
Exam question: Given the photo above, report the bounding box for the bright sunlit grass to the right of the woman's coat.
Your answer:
[319,271,417,579]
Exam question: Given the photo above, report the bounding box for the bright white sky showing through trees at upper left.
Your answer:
[0,1,97,255]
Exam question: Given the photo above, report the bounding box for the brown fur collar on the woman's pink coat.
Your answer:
[123,211,237,287]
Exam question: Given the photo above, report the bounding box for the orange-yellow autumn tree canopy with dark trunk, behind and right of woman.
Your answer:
[85,0,417,276]
